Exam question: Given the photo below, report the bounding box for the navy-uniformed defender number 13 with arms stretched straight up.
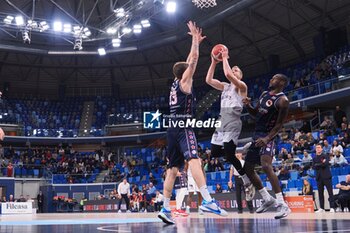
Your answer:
[158,21,227,224]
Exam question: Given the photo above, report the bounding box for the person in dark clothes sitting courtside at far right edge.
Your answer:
[334,175,350,212]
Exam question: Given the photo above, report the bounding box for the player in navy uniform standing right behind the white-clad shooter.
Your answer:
[243,74,291,219]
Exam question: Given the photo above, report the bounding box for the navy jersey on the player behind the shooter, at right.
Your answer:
[255,91,285,133]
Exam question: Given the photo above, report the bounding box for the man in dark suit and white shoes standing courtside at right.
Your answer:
[313,144,335,213]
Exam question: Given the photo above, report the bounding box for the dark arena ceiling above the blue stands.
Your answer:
[0,0,350,95]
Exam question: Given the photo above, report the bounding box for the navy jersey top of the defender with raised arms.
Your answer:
[169,79,196,116]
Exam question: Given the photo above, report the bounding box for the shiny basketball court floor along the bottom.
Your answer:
[0,213,350,233]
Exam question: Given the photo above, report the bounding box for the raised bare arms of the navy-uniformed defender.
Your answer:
[180,21,205,93]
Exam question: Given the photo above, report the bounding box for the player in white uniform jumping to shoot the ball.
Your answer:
[206,51,255,201]
